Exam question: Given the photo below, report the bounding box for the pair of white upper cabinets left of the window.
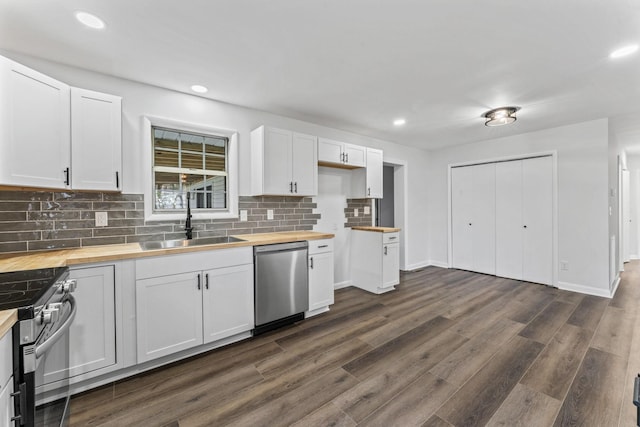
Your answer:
[0,56,122,191]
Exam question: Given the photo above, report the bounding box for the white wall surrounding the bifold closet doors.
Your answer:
[427,119,609,295]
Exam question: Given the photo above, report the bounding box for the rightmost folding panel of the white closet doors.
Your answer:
[522,157,553,285]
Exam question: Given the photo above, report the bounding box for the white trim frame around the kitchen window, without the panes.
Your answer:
[142,116,238,221]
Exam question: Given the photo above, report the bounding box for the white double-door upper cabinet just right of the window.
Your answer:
[251,126,318,196]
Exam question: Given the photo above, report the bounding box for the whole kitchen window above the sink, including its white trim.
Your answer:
[142,116,238,221]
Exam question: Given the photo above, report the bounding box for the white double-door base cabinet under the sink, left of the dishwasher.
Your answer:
[136,247,254,363]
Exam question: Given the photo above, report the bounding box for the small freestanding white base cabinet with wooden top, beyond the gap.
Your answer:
[351,230,400,294]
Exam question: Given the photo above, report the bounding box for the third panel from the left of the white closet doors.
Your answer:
[496,160,524,280]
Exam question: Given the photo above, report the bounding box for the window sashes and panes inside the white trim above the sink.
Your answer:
[152,126,229,212]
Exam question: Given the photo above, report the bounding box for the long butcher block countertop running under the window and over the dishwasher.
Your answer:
[0,231,334,273]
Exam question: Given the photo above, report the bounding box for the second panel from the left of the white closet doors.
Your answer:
[471,163,496,274]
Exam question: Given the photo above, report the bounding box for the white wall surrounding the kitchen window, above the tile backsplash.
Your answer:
[2,52,428,282]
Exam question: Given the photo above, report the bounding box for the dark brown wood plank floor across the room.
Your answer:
[71,261,640,427]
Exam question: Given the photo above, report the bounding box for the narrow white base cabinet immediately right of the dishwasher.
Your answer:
[306,239,334,317]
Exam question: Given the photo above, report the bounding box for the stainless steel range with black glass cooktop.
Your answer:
[0,267,77,427]
